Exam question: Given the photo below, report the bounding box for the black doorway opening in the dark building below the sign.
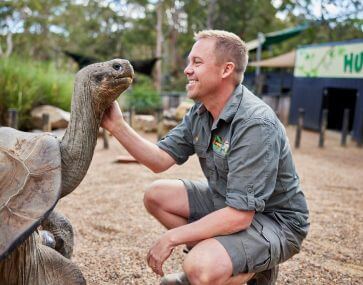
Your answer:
[323,88,358,131]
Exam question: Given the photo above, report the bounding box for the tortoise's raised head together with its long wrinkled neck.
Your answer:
[60,60,134,197]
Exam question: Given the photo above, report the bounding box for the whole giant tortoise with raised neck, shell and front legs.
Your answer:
[0,59,134,285]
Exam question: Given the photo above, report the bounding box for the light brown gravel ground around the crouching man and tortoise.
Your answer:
[57,127,363,284]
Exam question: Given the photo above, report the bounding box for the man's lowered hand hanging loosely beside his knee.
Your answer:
[146,235,174,276]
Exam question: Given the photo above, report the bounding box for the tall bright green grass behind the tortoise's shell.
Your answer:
[0,57,74,129]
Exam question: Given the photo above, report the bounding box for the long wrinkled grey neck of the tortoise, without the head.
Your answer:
[60,84,103,197]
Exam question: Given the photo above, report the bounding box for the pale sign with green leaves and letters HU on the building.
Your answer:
[294,42,363,78]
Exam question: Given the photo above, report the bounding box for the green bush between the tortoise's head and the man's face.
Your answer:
[125,75,161,114]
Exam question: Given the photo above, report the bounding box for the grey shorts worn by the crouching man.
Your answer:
[181,179,302,275]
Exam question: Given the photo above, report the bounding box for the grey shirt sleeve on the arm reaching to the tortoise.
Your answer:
[157,110,194,164]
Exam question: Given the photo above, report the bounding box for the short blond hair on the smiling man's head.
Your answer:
[194,30,248,84]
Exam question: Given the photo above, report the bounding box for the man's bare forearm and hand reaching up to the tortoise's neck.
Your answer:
[101,102,175,173]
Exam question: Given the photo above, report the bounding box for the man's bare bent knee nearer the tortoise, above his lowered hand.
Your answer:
[144,179,189,229]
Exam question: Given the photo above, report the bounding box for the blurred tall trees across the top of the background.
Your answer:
[0,0,363,93]
